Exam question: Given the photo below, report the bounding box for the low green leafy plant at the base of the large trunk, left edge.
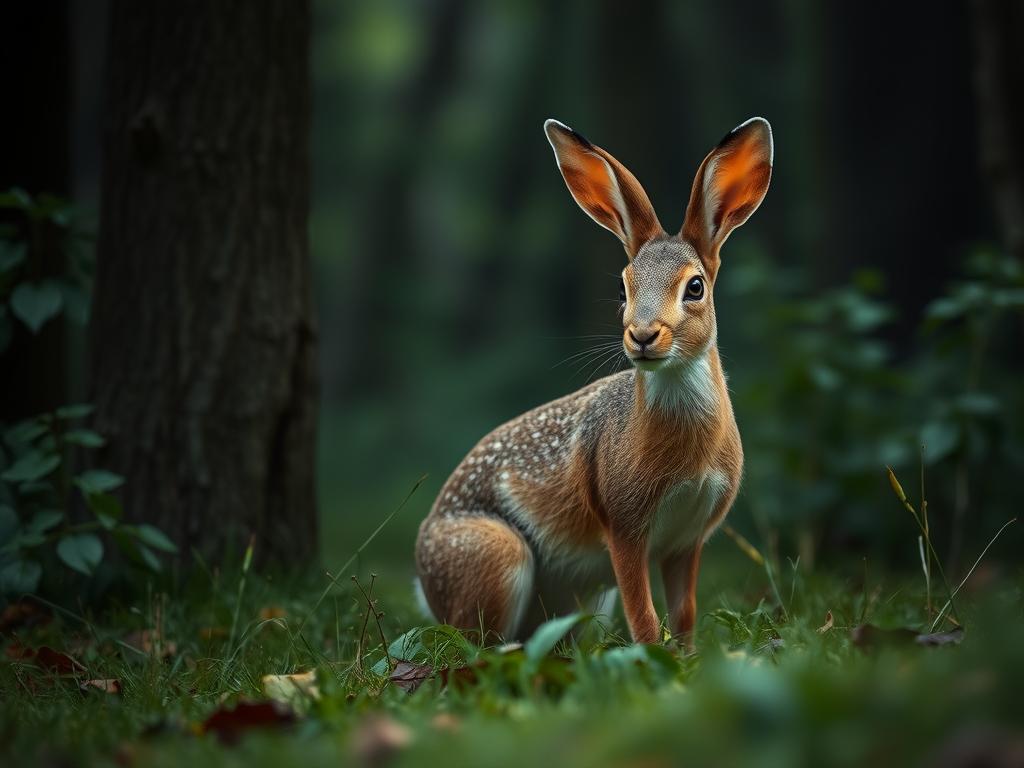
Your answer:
[0,404,177,594]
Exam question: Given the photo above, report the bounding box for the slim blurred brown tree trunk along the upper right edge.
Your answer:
[972,0,1024,261]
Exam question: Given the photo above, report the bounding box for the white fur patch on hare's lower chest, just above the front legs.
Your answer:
[648,470,729,557]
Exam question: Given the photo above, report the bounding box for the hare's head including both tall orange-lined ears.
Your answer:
[544,118,773,370]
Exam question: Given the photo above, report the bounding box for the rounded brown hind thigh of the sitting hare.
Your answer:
[416,516,534,639]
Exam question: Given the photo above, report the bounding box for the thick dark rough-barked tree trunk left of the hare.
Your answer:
[91,0,316,562]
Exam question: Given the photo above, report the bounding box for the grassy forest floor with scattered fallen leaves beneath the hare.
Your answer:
[0,543,1024,768]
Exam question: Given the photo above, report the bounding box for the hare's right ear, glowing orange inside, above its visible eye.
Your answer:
[679,118,775,273]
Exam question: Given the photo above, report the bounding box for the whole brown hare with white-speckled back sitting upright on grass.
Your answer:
[416,118,774,645]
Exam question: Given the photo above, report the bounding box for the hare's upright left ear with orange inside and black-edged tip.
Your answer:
[544,120,665,259]
